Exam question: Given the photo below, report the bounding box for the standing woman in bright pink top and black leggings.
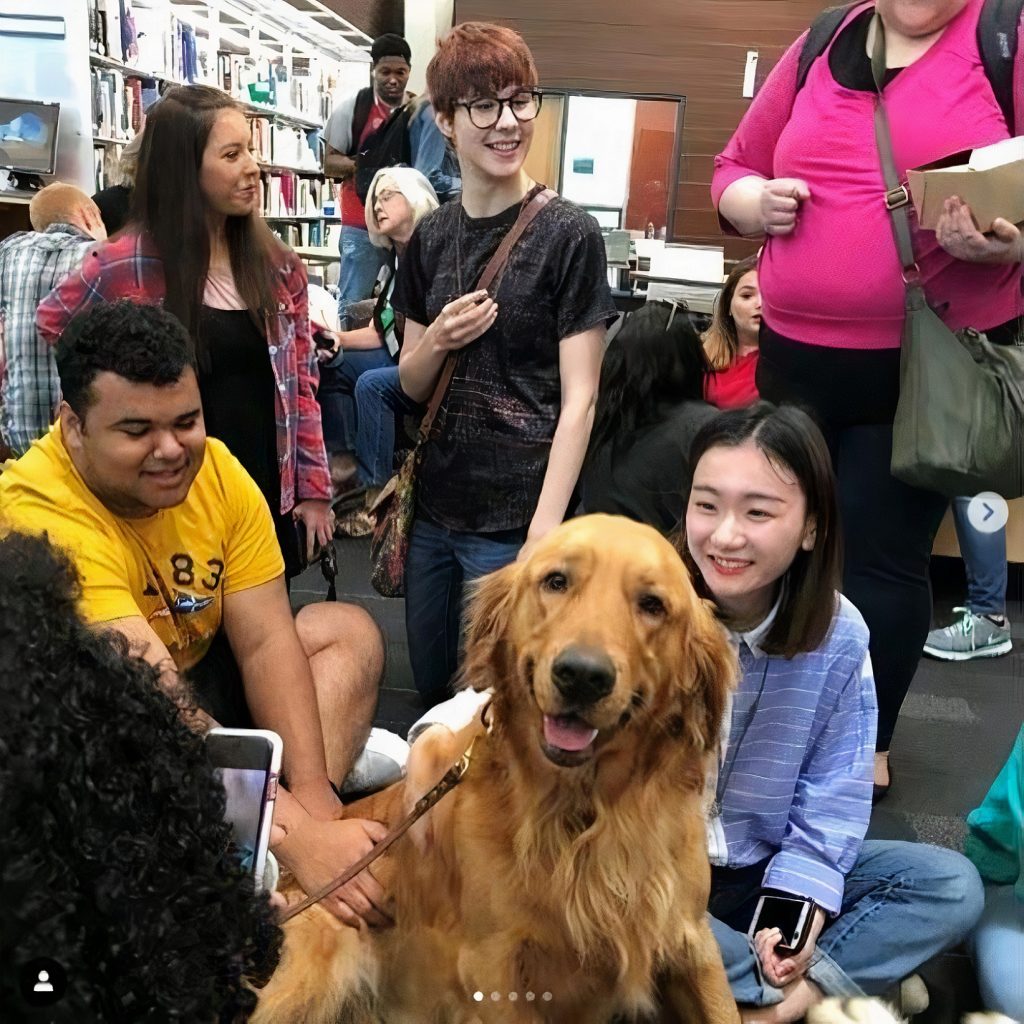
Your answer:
[712,0,1024,796]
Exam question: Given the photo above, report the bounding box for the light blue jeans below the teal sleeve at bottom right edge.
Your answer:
[973,886,1024,1020]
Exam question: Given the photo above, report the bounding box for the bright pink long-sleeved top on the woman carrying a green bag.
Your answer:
[712,0,1024,349]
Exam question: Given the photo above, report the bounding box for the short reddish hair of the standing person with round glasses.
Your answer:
[427,22,538,118]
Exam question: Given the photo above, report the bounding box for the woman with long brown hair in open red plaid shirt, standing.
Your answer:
[37,85,332,575]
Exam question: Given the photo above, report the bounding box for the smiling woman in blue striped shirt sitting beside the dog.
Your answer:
[684,402,982,1022]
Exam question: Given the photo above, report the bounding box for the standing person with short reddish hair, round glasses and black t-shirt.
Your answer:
[392,23,615,706]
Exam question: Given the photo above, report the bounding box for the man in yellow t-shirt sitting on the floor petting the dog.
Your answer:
[0,301,387,925]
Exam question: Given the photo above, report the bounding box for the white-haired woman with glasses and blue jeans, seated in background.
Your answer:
[317,167,438,536]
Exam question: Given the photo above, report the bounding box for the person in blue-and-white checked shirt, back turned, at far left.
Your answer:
[0,181,106,456]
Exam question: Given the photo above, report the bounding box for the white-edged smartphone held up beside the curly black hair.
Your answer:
[206,728,283,890]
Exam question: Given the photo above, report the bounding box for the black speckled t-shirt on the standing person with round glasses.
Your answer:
[391,188,615,532]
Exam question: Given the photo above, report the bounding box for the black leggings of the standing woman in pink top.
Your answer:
[757,325,949,751]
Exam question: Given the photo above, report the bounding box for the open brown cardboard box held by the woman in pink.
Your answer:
[906,138,1024,231]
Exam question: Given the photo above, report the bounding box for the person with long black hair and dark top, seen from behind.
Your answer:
[580,302,715,534]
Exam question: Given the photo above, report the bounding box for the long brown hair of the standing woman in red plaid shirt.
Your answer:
[131,85,283,370]
